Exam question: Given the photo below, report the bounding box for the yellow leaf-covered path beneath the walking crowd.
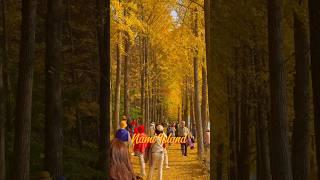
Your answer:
[131,144,209,180]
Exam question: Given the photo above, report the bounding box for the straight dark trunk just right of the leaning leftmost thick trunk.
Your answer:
[45,0,64,178]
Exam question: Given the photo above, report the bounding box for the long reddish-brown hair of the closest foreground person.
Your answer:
[109,138,137,180]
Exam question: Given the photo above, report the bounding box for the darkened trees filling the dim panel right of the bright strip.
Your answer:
[205,0,320,180]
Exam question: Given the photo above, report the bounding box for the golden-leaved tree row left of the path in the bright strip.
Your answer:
[111,1,184,130]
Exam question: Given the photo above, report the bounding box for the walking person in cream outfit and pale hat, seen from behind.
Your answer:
[147,125,164,180]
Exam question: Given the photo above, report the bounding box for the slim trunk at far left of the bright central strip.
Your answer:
[113,32,121,132]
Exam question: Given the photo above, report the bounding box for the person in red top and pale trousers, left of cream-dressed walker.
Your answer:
[133,125,148,177]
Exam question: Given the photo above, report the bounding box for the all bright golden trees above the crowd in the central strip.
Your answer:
[111,0,208,165]
